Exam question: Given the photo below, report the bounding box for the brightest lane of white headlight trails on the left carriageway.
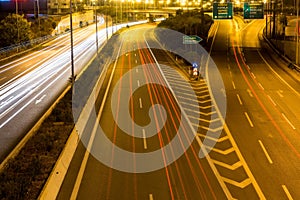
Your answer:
[0,23,104,126]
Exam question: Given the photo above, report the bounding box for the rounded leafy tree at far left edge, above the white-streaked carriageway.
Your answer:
[0,14,33,47]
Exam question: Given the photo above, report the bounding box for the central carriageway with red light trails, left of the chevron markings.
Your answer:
[58,26,230,199]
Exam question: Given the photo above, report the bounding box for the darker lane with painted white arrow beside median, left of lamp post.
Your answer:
[0,57,70,160]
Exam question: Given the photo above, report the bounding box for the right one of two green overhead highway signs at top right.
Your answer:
[244,2,264,19]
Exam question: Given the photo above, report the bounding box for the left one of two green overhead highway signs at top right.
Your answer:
[213,2,233,19]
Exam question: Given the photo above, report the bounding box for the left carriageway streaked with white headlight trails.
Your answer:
[0,19,145,162]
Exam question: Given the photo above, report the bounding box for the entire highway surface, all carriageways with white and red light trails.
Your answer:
[0,13,300,200]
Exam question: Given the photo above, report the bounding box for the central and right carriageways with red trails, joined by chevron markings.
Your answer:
[54,18,300,199]
